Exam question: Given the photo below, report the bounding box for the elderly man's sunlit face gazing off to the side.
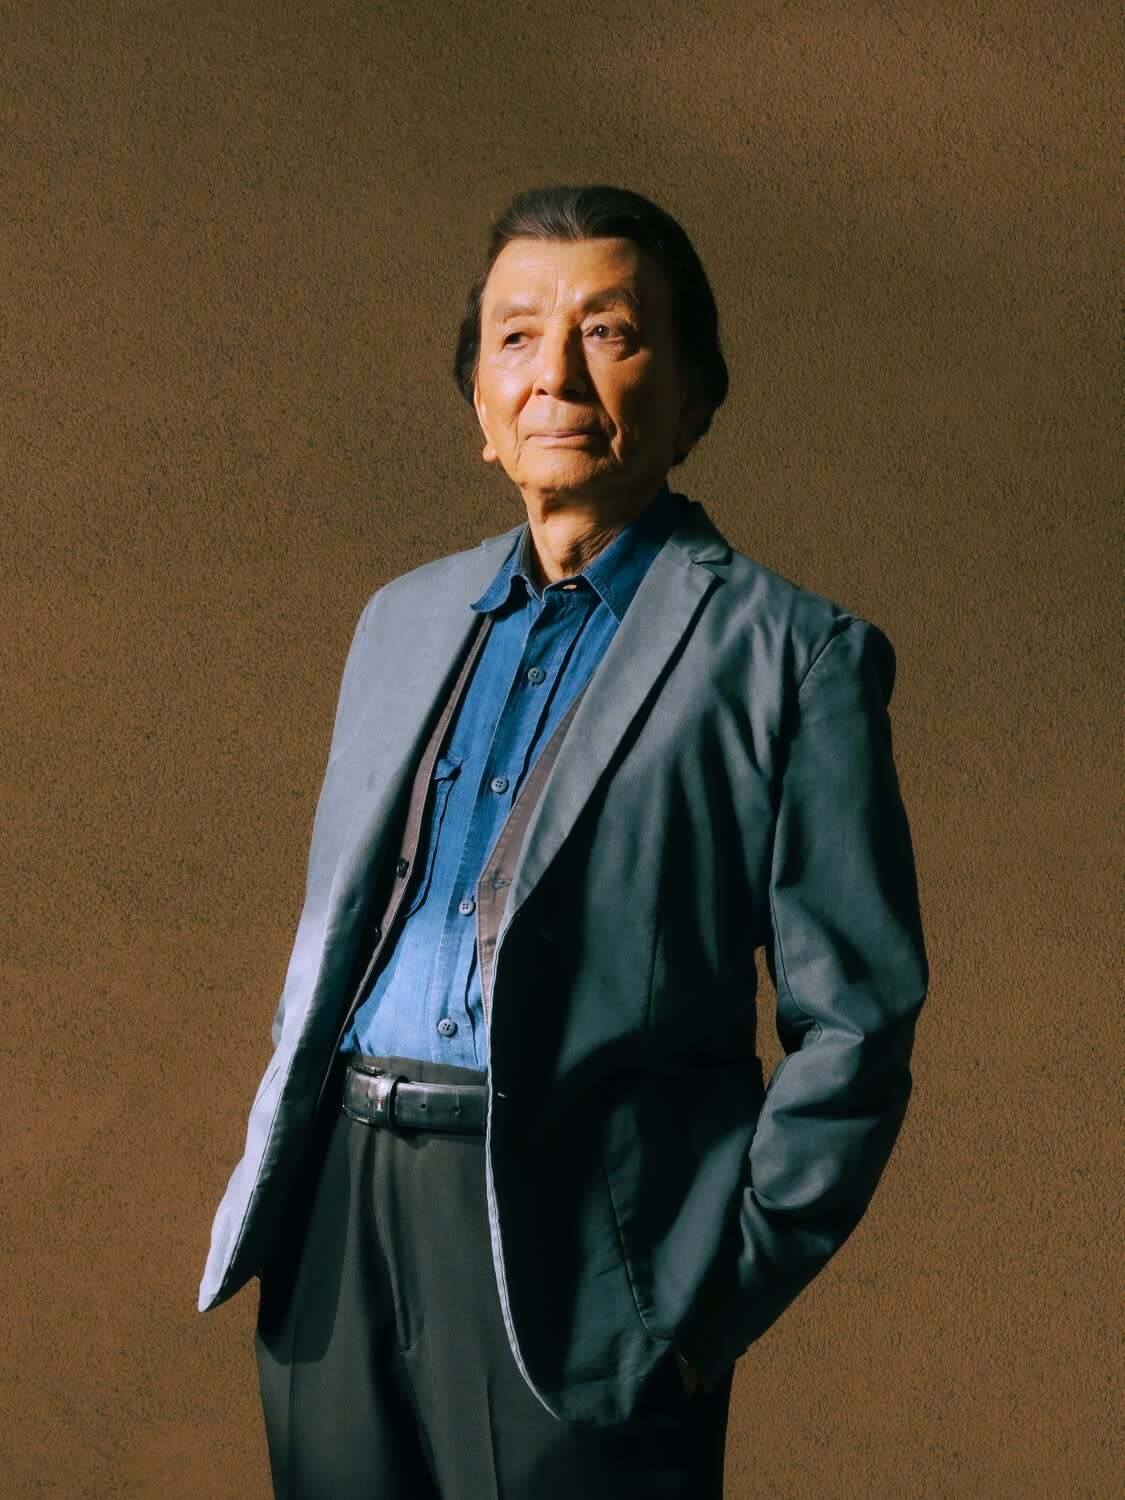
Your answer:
[474,239,705,506]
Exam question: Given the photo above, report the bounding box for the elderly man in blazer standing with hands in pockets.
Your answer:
[200,186,927,1500]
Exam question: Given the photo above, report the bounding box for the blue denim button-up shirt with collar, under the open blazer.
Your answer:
[341,483,686,1071]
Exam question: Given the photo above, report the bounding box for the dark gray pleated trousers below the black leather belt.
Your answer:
[255,1058,734,1500]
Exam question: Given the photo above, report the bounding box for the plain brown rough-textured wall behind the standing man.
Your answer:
[0,0,1122,1500]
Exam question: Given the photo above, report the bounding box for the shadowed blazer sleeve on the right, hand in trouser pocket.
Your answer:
[675,618,929,1388]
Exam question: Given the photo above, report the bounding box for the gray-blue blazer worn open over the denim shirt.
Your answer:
[200,503,927,1425]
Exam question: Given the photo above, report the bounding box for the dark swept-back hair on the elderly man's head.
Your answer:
[453,185,729,465]
